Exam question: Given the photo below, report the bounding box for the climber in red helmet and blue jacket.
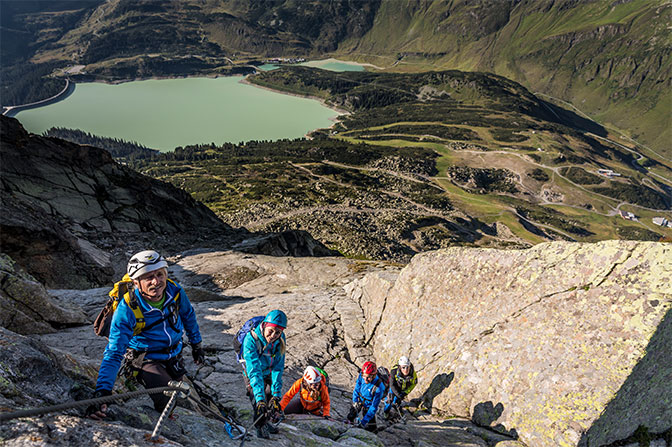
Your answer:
[348,362,385,432]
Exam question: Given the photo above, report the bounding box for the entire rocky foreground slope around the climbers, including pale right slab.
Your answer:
[0,242,672,447]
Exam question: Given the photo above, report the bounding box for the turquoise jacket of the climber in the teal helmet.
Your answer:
[243,323,286,402]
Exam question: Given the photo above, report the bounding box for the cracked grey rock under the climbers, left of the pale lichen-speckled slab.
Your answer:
[0,250,493,447]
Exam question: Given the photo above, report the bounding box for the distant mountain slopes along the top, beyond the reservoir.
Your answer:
[3,0,672,156]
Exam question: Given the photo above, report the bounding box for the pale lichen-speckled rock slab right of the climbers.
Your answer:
[347,241,672,447]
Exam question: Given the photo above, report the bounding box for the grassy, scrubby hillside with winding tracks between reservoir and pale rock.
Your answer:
[121,67,672,260]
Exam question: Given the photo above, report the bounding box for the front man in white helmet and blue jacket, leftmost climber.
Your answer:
[87,250,205,419]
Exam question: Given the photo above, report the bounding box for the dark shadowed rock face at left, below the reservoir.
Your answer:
[0,116,230,288]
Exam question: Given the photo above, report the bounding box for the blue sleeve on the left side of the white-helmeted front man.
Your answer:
[96,300,135,391]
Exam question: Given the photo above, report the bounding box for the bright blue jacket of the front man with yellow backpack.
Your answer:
[96,280,201,390]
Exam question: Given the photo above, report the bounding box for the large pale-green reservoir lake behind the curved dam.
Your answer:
[16,76,338,152]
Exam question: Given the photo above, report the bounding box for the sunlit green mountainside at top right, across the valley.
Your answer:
[340,0,672,158]
